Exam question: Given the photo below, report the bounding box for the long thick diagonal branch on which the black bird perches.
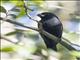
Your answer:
[0,17,80,51]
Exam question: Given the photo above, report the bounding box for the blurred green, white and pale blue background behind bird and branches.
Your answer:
[0,0,80,60]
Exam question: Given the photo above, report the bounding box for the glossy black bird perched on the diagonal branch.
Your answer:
[37,12,63,51]
